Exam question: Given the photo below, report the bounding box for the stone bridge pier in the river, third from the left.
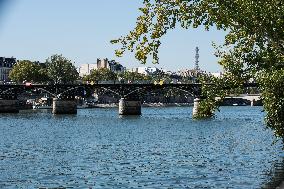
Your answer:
[119,98,141,115]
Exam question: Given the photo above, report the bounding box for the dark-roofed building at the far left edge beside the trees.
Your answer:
[0,57,17,82]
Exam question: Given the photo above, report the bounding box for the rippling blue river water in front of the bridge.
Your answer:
[0,107,284,189]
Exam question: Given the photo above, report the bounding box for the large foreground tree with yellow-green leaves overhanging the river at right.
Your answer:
[111,0,284,137]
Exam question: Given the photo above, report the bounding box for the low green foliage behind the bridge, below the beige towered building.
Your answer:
[83,68,117,83]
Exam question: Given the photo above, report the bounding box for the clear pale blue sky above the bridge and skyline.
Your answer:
[0,0,224,72]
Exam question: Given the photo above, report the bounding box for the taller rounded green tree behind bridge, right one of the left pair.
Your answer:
[46,55,79,84]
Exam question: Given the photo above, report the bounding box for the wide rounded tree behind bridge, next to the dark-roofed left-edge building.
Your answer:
[9,60,47,83]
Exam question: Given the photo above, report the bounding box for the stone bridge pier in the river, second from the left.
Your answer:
[52,98,77,114]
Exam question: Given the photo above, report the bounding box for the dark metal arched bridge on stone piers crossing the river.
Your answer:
[0,83,256,115]
